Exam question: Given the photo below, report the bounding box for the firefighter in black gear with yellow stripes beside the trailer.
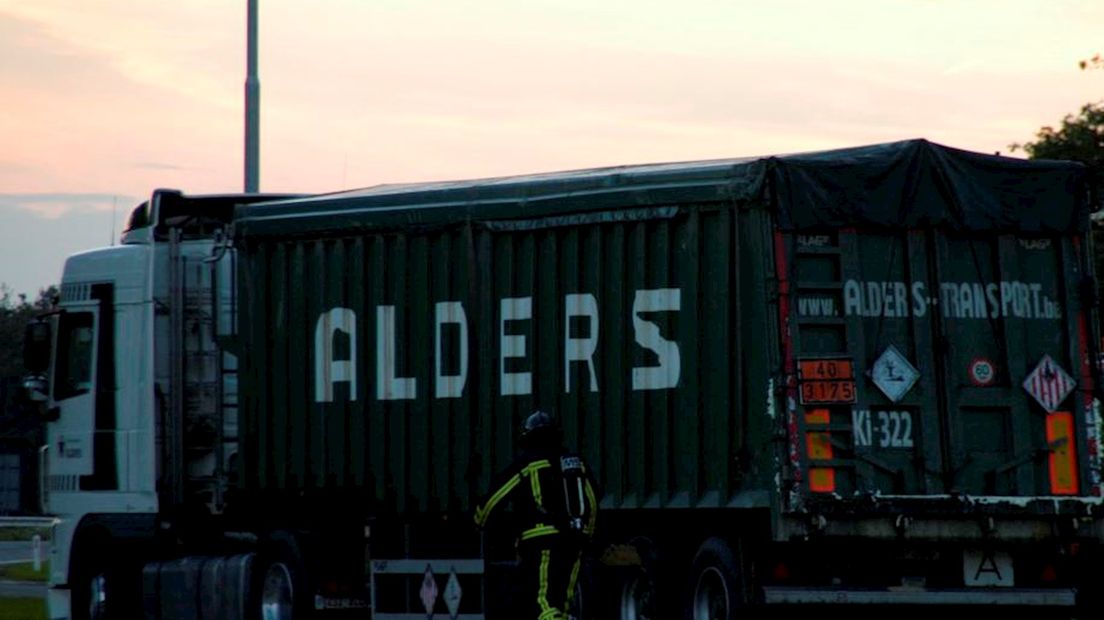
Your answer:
[475,410,598,620]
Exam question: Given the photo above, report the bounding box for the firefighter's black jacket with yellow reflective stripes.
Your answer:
[475,451,598,543]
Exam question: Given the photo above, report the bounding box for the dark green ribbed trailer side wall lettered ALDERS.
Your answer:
[240,157,771,511]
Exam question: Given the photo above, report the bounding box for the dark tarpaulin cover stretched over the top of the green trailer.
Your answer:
[236,140,1089,237]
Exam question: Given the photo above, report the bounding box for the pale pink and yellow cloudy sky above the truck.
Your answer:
[0,0,1104,291]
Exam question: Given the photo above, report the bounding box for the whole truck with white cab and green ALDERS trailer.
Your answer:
[24,140,1104,620]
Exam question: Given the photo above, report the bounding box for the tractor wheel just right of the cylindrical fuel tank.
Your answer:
[254,531,312,620]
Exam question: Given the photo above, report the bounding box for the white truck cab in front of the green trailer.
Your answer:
[24,190,295,619]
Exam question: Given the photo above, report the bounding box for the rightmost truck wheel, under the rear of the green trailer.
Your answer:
[687,538,747,620]
